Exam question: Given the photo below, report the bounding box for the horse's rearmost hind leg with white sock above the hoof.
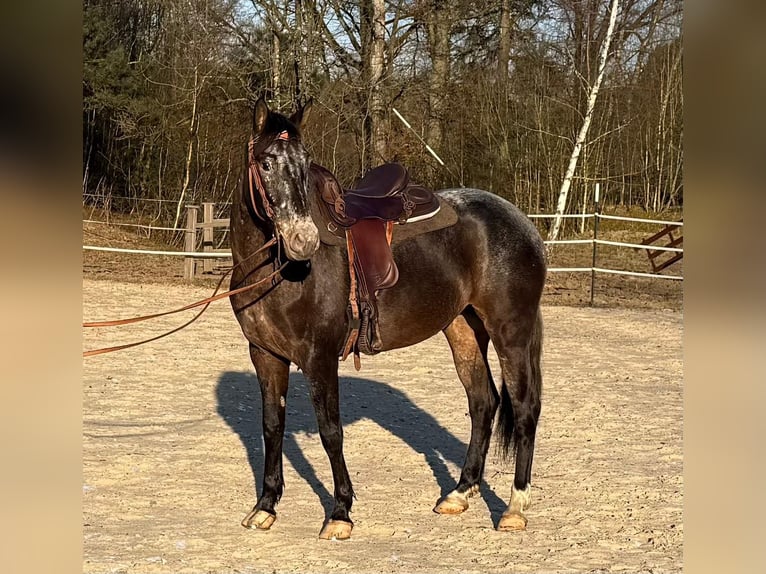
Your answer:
[485,310,543,530]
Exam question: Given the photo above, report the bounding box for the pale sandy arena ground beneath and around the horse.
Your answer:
[83,279,683,574]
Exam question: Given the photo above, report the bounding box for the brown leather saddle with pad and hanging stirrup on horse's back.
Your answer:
[310,163,457,370]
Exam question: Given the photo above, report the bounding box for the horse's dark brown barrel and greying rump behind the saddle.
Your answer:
[378,188,545,349]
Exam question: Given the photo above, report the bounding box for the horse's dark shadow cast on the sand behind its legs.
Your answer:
[216,371,505,524]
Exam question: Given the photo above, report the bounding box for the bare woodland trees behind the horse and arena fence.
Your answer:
[83,0,683,234]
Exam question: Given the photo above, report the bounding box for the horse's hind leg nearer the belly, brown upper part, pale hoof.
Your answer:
[434,308,498,514]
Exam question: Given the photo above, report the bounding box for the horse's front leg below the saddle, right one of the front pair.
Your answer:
[304,355,354,540]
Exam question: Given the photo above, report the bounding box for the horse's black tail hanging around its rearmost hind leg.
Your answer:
[496,308,543,458]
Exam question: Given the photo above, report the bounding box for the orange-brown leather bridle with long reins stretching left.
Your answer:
[82,131,302,357]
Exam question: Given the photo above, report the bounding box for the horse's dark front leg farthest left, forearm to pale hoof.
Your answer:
[242,345,290,530]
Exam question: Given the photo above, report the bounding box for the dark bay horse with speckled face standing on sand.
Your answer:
[231,99,546,539]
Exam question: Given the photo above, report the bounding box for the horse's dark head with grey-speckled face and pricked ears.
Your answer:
[247,98,319,261]
